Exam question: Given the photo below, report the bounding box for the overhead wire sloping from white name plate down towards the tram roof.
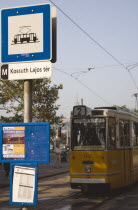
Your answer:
[53,67,112,106]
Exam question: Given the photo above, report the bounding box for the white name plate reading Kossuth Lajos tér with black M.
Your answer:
[0,61,52,80]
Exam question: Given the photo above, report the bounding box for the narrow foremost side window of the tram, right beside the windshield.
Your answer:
[108,118,116,148]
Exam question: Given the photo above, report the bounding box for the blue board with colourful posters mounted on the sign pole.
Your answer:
[0,123,50,163]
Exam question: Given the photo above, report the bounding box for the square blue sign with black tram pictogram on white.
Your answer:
[1,4,52,63]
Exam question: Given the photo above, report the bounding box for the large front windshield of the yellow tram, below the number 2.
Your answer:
[71,117,106,150]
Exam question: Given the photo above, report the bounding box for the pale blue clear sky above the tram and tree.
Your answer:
[0,0,138,117]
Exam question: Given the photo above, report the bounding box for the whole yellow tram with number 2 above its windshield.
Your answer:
[70,105,138,192]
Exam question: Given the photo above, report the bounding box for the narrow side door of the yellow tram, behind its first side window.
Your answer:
[119,120,131,185]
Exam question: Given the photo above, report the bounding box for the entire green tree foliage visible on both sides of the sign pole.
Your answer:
[0,79,63,124]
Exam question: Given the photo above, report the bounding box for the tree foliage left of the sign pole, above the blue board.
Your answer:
[0,81,23,122]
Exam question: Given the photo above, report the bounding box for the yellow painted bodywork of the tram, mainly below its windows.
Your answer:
[70,106,138,192]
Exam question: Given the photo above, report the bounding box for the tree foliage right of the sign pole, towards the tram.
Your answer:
[33,80,63,124]
